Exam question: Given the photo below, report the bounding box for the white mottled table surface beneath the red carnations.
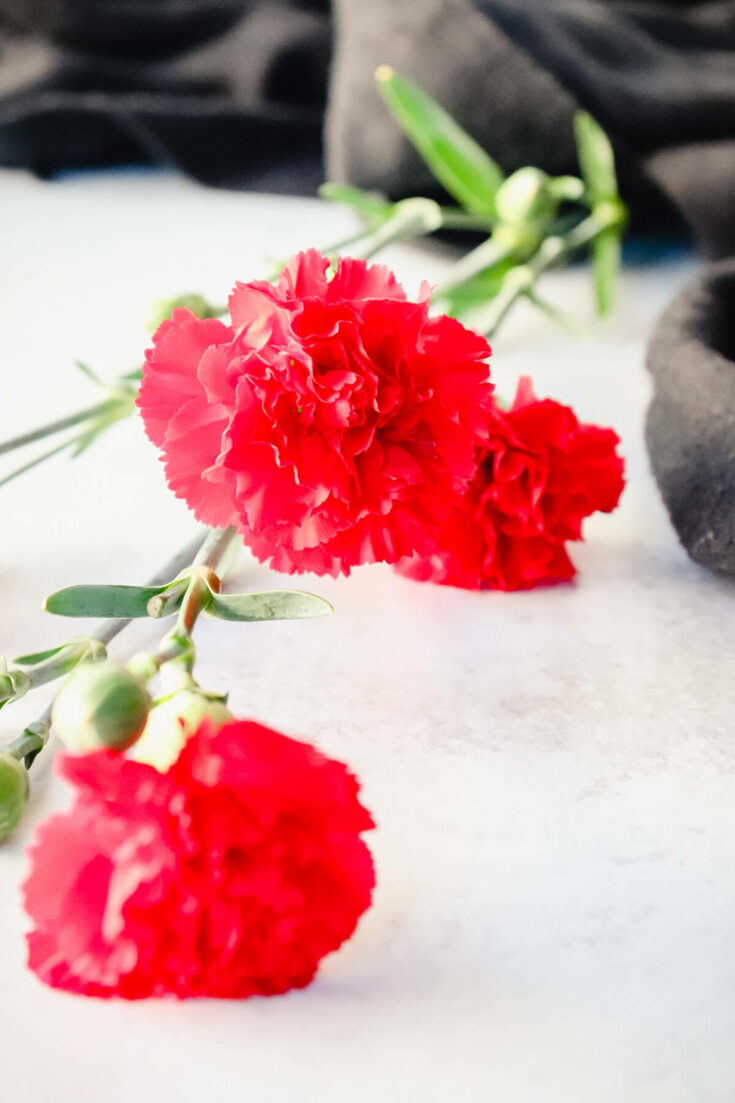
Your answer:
[0,167,735,1103]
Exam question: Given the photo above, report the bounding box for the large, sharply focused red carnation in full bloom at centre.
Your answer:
[138,250,492,575]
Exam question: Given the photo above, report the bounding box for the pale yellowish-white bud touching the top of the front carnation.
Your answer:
[131,688,233,771]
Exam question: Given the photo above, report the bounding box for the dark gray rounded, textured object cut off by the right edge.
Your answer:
[646,260,735,575]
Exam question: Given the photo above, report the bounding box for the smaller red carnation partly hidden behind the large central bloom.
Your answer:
[398,378,625,590]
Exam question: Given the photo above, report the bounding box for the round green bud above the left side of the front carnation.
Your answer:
[52,658,151,753]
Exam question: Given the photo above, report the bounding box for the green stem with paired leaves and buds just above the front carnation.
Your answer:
[0,527,332,840]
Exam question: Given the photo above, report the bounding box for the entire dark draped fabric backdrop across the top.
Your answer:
[0,0,735,257]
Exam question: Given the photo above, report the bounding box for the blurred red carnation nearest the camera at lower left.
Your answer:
[24,721,374,999]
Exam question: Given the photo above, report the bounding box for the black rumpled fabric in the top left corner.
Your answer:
[0,0,331,193]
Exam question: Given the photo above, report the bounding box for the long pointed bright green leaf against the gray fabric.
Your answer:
[375,65,503,214]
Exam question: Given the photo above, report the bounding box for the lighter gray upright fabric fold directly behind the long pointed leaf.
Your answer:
[327,0,577,193]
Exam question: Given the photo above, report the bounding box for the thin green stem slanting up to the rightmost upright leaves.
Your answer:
[473,204,622,336]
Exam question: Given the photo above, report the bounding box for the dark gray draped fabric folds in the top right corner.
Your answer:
[470,0,735,257]
